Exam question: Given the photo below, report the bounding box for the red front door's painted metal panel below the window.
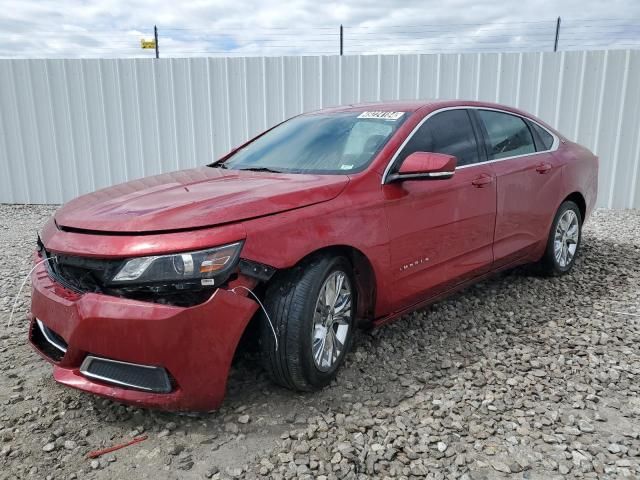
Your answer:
[385,166,496,309]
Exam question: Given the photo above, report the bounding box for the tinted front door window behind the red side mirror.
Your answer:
[396,110,478,166]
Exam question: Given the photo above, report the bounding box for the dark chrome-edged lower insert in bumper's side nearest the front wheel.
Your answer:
[80,355,171,393]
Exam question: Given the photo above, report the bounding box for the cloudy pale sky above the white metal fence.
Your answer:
[0,0,640,58]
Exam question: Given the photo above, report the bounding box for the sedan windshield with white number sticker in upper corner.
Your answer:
[212,112,407,174]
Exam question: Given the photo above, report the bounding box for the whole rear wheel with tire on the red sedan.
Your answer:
[540,200,582,275]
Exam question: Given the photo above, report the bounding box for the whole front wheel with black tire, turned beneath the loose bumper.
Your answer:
[260,255,357,391]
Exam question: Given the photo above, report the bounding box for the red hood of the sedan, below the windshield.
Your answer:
[55,167,349,233]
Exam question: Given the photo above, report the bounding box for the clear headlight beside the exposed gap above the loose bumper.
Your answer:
[110,242,242,286]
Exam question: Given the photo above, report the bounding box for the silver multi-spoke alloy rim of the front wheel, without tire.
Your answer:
[311,271,352,372]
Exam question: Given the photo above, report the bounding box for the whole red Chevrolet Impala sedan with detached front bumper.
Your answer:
[29,101,598,410]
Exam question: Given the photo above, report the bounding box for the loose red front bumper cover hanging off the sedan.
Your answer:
[29,255,258,411]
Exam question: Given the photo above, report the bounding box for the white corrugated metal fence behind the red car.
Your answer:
[0,50,640,208]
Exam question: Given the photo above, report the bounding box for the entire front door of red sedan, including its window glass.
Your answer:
[383,109,496,310]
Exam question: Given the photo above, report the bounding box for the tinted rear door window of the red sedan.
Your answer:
[478,110,536,160]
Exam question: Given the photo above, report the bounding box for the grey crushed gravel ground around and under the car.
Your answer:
[0,206,640,479]
